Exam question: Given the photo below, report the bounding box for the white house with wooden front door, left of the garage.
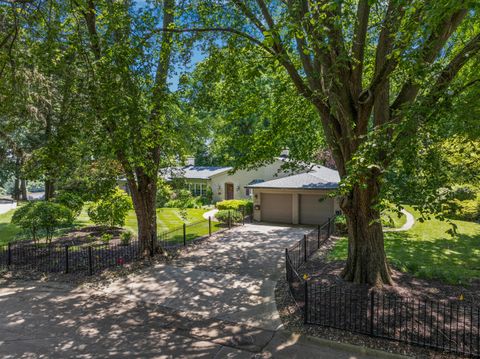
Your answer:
[169,155,291,202]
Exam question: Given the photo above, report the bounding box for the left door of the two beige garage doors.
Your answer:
[260,193,292,223]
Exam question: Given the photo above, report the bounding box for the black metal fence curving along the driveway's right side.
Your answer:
[286,224,480,358]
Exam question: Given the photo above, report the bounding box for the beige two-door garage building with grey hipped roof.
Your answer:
[247,166,340,224]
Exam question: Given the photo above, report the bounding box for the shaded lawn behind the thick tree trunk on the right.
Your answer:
[329,207,480,285]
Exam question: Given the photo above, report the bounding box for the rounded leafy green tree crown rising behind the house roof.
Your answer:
[179,47,325,168]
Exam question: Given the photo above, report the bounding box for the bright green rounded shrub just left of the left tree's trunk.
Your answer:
[88,188,133,227]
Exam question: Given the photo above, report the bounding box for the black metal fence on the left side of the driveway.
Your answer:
[0,211,245,275]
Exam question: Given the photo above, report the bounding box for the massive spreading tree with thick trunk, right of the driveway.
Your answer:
[181,0,480,284]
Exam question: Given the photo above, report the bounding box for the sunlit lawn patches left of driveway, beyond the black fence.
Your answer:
[0,208,220,245]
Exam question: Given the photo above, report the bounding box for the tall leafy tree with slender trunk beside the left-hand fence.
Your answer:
[72,0,199,253]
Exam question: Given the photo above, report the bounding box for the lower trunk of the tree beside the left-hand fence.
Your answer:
[129,173,159,255]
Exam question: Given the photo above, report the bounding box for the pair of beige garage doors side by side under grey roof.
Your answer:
[261,193,334,224]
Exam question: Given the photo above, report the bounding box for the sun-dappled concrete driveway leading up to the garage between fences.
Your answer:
[100,225,307,330]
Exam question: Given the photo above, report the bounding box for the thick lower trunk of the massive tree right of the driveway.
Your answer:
[342,178,393,286]
